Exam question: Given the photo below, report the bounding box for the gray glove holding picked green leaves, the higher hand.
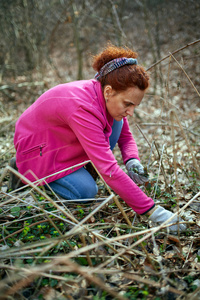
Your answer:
[126,158,149,184]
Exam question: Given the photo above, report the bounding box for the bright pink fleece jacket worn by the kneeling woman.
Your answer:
[14,80,154,214]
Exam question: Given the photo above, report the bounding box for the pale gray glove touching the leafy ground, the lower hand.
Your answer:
[149,205,187,234]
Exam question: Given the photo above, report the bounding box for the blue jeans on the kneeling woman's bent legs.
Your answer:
[49,119,123,200]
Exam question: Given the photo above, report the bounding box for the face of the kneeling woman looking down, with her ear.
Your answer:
[104,85,144,121]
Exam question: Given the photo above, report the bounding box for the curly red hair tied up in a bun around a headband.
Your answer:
[92,45,149,91]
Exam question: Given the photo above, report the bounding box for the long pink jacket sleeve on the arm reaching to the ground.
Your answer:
[69,107,154,214]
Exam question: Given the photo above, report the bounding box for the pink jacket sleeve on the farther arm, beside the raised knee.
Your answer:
[118,118,140,164]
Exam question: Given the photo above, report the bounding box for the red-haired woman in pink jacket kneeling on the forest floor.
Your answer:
[14,46,185,232]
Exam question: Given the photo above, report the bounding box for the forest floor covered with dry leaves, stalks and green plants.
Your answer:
[0,38,200,300]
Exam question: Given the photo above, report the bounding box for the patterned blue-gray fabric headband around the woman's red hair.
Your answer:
[94,57,138,80]
